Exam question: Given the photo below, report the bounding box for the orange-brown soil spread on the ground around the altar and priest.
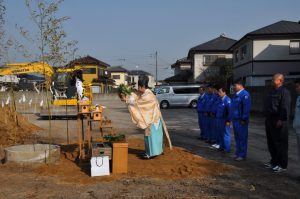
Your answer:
[35,139,231,184]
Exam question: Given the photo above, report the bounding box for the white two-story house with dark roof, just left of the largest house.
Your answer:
[187,35,236,82]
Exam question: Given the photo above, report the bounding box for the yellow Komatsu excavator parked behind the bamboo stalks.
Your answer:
[0,62,92,118]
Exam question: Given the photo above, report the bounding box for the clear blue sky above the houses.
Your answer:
[5,0,300,79]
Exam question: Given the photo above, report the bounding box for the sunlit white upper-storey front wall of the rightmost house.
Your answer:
[253,39,300,61]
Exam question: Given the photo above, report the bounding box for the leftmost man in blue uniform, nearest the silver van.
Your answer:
[197,87,207,140]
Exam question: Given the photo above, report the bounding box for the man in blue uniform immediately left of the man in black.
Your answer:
[231,80,251,161]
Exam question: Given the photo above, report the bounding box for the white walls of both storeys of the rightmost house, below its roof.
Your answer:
[233,39,300,83]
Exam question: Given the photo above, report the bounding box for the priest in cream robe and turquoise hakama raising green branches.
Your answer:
[118,75,172,159]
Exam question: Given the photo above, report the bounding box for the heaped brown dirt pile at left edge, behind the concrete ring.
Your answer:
[0,106,41,146]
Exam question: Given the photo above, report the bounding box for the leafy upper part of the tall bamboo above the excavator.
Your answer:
[25,0,78,67]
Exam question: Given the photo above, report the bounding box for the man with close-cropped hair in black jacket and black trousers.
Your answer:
[264,74,291,173]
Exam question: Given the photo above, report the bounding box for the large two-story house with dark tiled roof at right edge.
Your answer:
[231,21,300,86]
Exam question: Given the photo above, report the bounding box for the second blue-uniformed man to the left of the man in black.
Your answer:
[216,87,231,153]
